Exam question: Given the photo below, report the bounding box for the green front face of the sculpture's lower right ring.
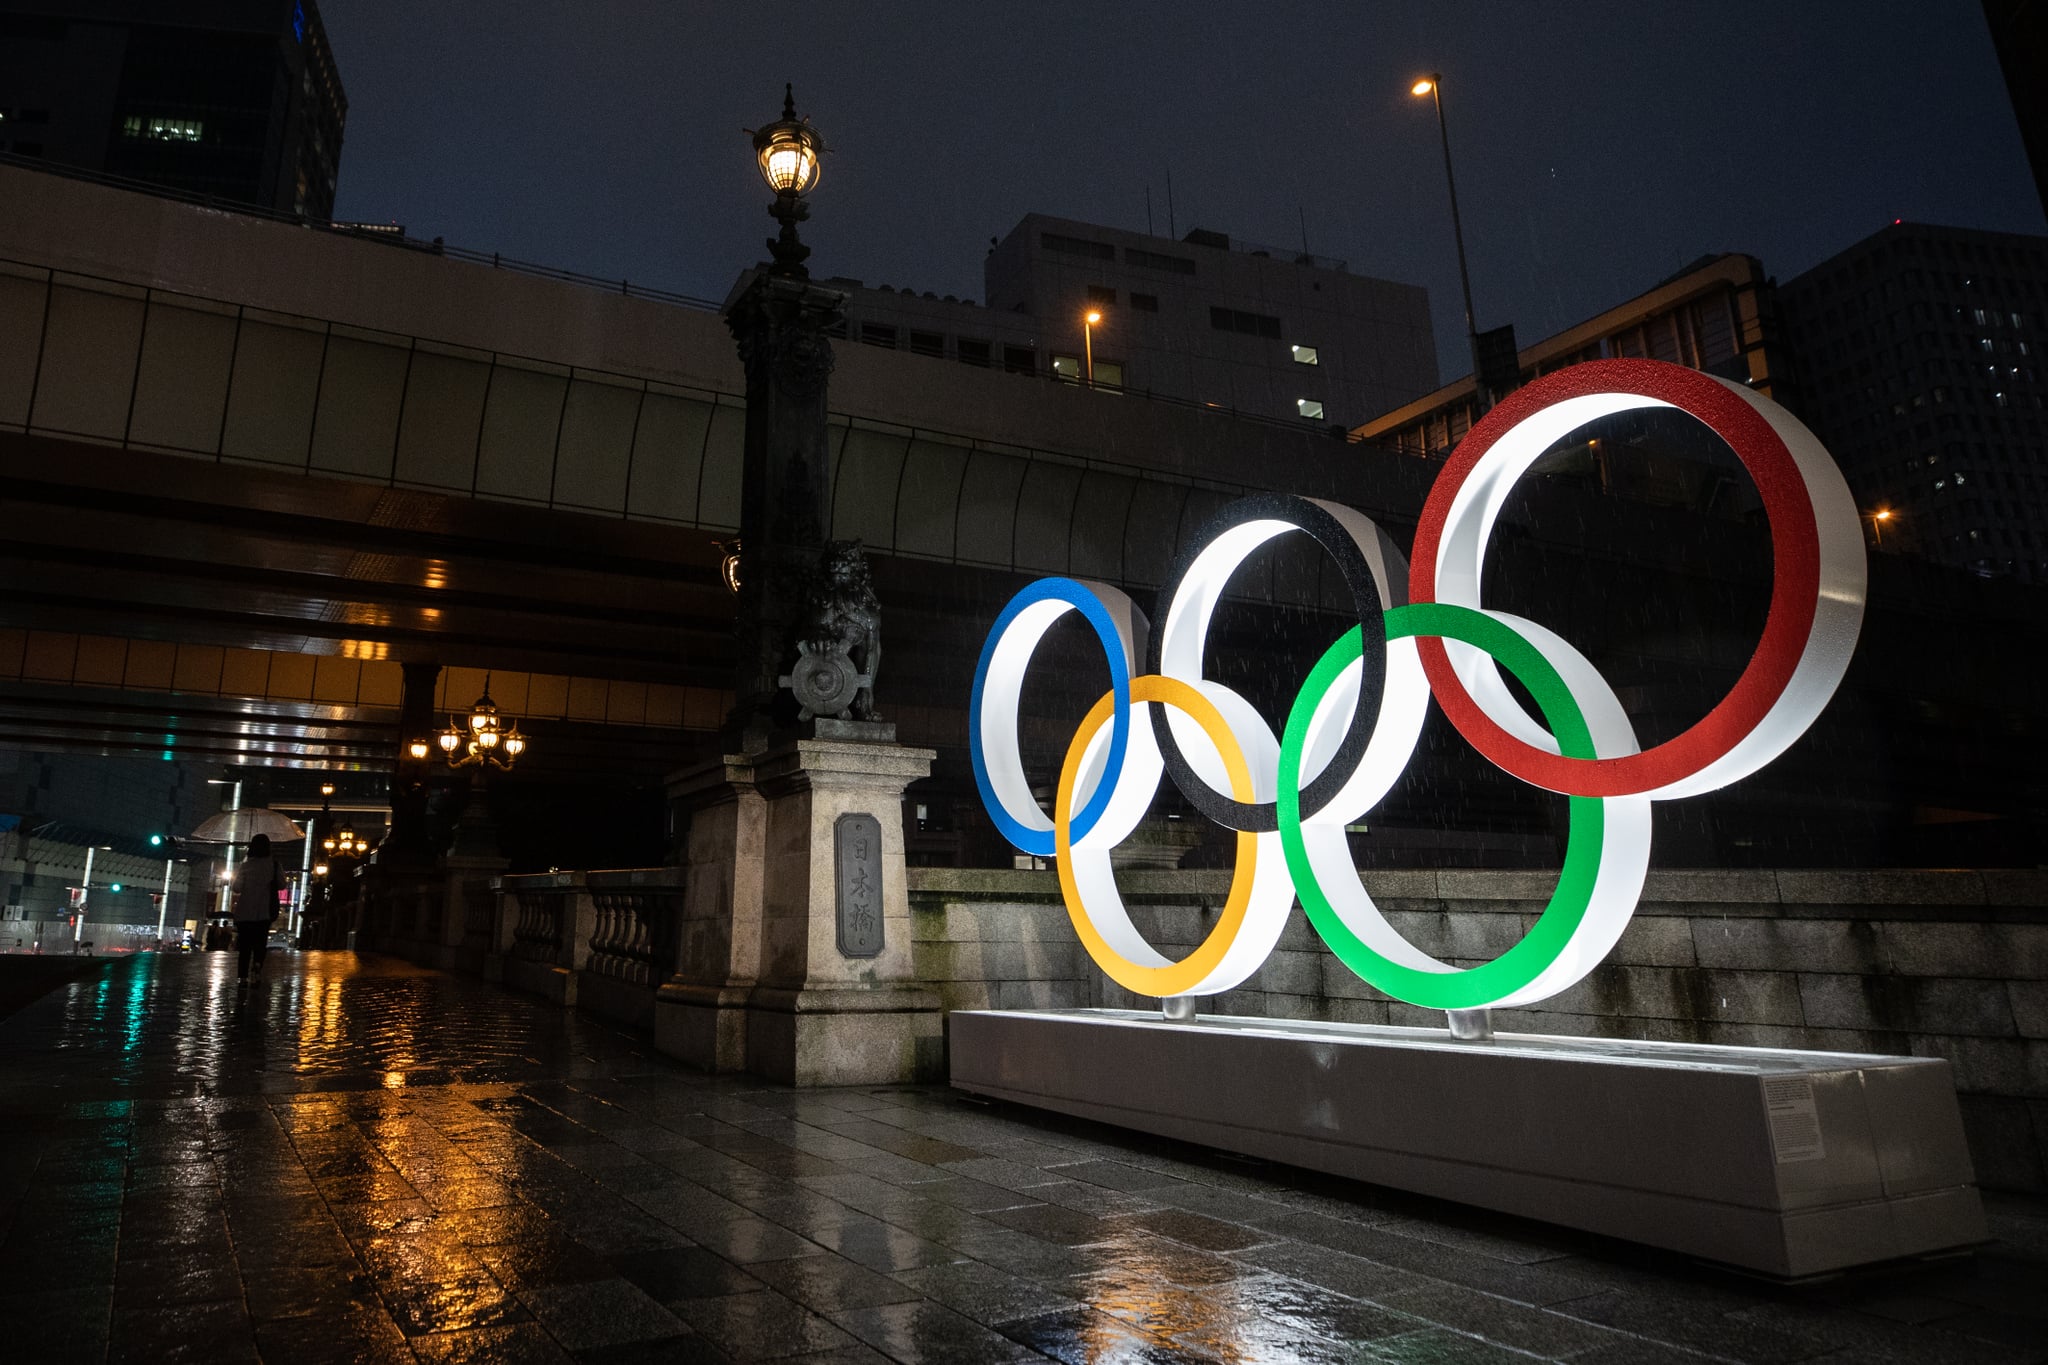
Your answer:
[1276,602,1606,1009]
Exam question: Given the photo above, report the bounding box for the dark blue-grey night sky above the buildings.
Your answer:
[322,0,2044,379]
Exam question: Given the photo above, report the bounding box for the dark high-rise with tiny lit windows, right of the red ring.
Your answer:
[1780,223,2048,583]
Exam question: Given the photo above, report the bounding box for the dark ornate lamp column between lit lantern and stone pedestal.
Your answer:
[721,274,846,753]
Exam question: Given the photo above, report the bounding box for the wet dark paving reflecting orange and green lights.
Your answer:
[0,954,2048,1365]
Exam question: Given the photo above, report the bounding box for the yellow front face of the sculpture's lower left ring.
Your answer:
[1053,673,1257,999]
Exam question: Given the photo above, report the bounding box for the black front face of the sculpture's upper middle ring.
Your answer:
[1145,493,1386,835]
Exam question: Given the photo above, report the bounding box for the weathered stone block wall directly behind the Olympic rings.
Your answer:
[909,868,2048,1191]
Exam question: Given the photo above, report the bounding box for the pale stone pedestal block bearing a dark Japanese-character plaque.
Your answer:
[745,720,942,1085]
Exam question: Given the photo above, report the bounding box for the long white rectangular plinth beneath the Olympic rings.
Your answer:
[950,1009,1985,1279]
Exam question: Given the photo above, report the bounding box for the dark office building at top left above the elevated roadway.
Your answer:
[0,0,348,219]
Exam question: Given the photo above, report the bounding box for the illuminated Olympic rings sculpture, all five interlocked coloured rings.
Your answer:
[969,360,1866,1009]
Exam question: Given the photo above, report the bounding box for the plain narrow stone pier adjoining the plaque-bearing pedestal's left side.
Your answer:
[653,755,768,1070]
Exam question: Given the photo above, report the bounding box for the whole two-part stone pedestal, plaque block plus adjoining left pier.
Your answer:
[655,724,942,1085]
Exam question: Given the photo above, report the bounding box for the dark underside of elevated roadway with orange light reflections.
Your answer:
[0,432,731,774]
